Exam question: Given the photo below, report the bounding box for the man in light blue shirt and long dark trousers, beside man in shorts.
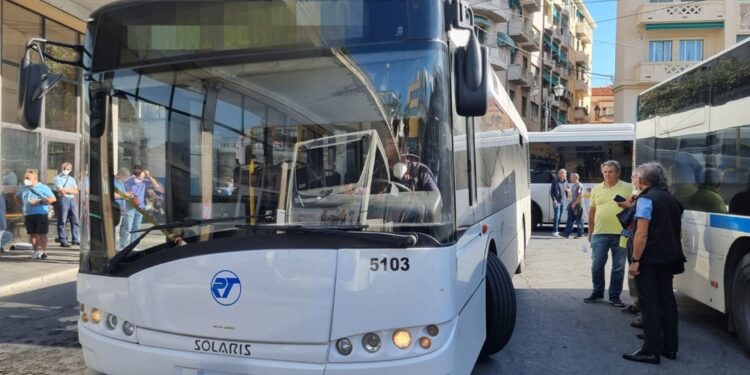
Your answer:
[55,162,81,247]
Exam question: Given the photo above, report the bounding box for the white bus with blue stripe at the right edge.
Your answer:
[636,41,750,353]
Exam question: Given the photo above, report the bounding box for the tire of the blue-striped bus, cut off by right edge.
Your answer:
[731,254,750,355]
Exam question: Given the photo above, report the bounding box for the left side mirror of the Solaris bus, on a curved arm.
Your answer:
[18,57,62,130]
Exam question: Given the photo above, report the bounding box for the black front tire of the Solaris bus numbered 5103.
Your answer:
[480,252,516,356]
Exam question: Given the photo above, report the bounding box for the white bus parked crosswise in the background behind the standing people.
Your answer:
[529,124,635,231]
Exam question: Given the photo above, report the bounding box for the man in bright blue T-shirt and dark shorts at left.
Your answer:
[15,170,56,259]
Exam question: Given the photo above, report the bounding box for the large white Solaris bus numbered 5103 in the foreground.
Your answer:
[21,0,530,374]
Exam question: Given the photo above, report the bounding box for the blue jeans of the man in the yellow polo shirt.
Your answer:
[591,234,627,299]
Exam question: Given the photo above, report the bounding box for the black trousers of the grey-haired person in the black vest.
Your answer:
[635,264,677,354]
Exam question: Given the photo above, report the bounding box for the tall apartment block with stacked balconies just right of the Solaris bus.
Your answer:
[468,0,596,131]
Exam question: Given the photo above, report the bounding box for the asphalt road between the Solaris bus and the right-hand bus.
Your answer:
[472,232,750,375]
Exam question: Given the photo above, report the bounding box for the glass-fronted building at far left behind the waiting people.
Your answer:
[0,0,109,226]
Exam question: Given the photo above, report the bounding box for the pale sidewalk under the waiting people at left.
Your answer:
[0,241,79,297]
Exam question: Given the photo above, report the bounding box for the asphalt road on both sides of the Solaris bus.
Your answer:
[0,233,750,375]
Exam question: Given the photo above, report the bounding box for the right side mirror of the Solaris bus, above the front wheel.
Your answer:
[455,33,489,116]
